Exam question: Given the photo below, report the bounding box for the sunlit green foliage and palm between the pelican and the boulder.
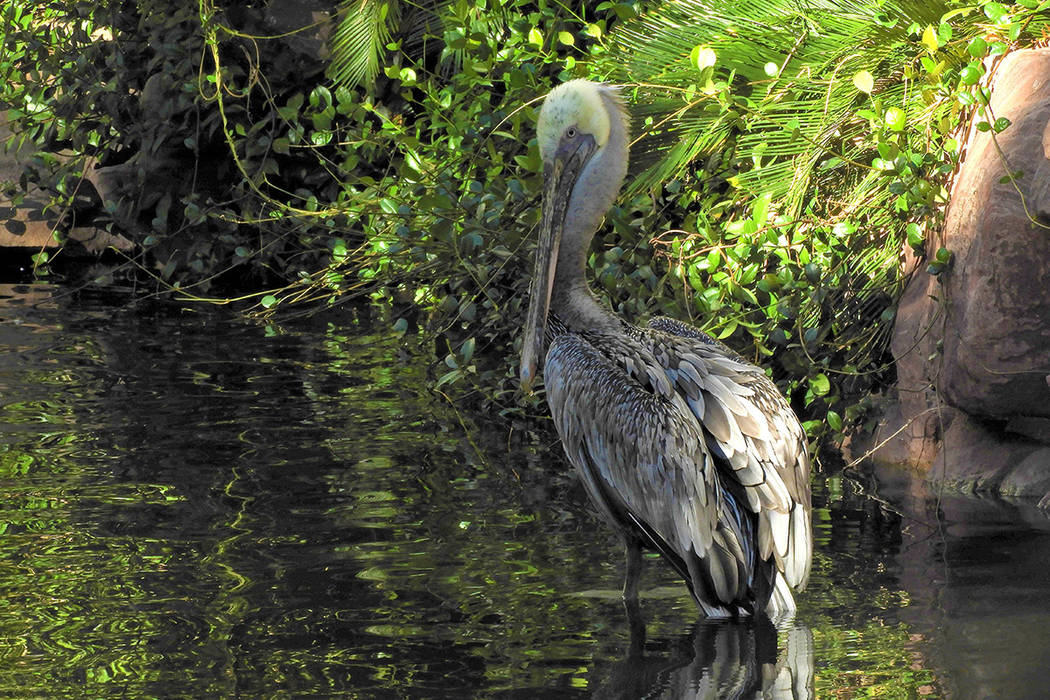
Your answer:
[596,0,1048,434]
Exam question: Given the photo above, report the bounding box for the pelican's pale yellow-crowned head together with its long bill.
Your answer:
[521,80,627,391]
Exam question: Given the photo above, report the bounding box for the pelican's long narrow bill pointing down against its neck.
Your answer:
[521,158,572,394]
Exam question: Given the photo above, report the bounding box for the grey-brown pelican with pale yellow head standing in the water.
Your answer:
[521,80,813,625]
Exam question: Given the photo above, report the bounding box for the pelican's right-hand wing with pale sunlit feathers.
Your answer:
[646,317,813,604]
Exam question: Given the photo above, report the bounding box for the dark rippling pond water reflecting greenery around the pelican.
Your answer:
[0,285,1050,698]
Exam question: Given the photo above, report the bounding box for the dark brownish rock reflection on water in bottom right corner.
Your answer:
[864,467,1050,698]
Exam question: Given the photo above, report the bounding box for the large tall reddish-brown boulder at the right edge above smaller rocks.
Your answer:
[893,49,1050,418]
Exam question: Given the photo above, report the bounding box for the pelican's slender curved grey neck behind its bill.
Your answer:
[550,90,628,330]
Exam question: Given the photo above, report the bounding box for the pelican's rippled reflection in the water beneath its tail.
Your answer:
[592,616,814,700]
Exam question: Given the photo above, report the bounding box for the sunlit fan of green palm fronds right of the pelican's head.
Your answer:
[609,0,948,196]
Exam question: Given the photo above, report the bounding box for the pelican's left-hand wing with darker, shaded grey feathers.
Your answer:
[544,334,754,614]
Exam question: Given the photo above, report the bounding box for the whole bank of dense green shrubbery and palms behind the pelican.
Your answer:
[6,0,1047,432]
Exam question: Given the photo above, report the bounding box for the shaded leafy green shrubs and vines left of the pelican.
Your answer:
[0,1,613,419]
